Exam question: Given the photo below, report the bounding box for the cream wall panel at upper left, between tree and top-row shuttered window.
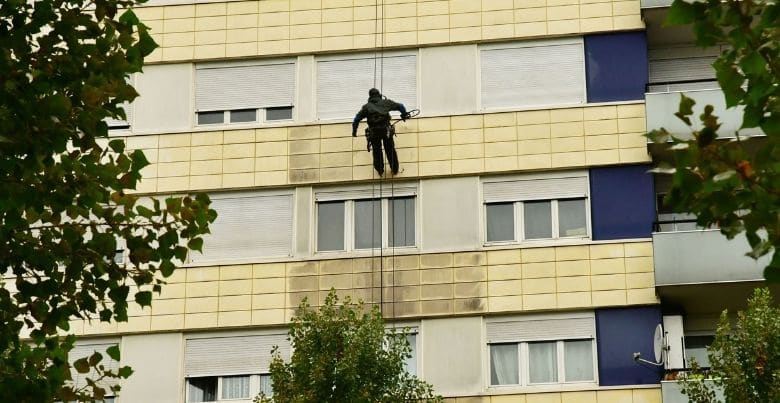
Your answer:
[133,63,193,133]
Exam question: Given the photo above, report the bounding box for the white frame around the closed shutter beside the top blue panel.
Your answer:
[476,36,588,113]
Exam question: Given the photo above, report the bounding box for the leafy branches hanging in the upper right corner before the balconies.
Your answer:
[650,0,780,281]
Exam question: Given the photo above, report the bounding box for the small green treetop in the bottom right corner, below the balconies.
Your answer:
[680,288,780,403]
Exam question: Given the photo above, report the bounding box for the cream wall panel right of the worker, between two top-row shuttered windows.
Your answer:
[420,45,477,116]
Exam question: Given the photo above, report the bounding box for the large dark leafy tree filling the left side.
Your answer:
[0,0,216,402]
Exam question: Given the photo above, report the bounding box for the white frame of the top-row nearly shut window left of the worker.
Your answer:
[192,58,300,130]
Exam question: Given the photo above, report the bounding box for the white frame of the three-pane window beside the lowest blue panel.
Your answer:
[484,312,599,392]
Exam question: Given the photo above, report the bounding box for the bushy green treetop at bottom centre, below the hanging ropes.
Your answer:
[255,290,441,403]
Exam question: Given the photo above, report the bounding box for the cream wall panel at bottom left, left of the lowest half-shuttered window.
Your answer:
[120,333,184,402]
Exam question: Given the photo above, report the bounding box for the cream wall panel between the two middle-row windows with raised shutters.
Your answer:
[420,176,480,251]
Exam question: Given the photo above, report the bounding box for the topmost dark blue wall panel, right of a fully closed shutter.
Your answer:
[585,31,647,102]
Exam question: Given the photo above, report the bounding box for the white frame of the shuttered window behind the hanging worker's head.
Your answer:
[312,49,422,122]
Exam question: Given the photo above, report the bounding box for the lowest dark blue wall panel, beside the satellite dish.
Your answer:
[596,306,663,386]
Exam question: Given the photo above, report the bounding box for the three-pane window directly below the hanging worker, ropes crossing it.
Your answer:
[315,185,417,252]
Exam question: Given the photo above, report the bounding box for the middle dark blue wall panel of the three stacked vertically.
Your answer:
[590,165,655,240]
